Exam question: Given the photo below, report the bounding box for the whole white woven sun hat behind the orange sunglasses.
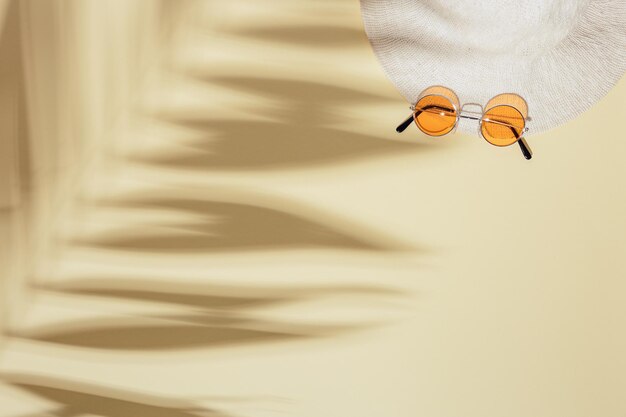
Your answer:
[361,0,626,134]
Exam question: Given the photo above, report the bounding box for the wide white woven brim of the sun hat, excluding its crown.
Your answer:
[361,0,626,133]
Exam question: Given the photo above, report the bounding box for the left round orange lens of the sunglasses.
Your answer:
[413,95,457,136]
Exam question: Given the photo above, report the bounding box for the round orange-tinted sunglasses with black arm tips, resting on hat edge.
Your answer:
[396,86,533,159]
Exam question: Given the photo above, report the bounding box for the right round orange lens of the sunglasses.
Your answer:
[480,106,526,146]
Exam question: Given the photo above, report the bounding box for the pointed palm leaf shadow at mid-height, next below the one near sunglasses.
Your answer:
[75,198,402,253]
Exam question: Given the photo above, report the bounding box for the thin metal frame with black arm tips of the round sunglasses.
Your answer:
[396,90,533,160]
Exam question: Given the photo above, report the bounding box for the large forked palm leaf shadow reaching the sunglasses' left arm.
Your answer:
[137,76,425,171]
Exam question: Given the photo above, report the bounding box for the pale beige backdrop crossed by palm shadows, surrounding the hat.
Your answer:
[0,0,626,417]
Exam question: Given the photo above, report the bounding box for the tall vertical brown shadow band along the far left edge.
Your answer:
[0,0,36,344]
